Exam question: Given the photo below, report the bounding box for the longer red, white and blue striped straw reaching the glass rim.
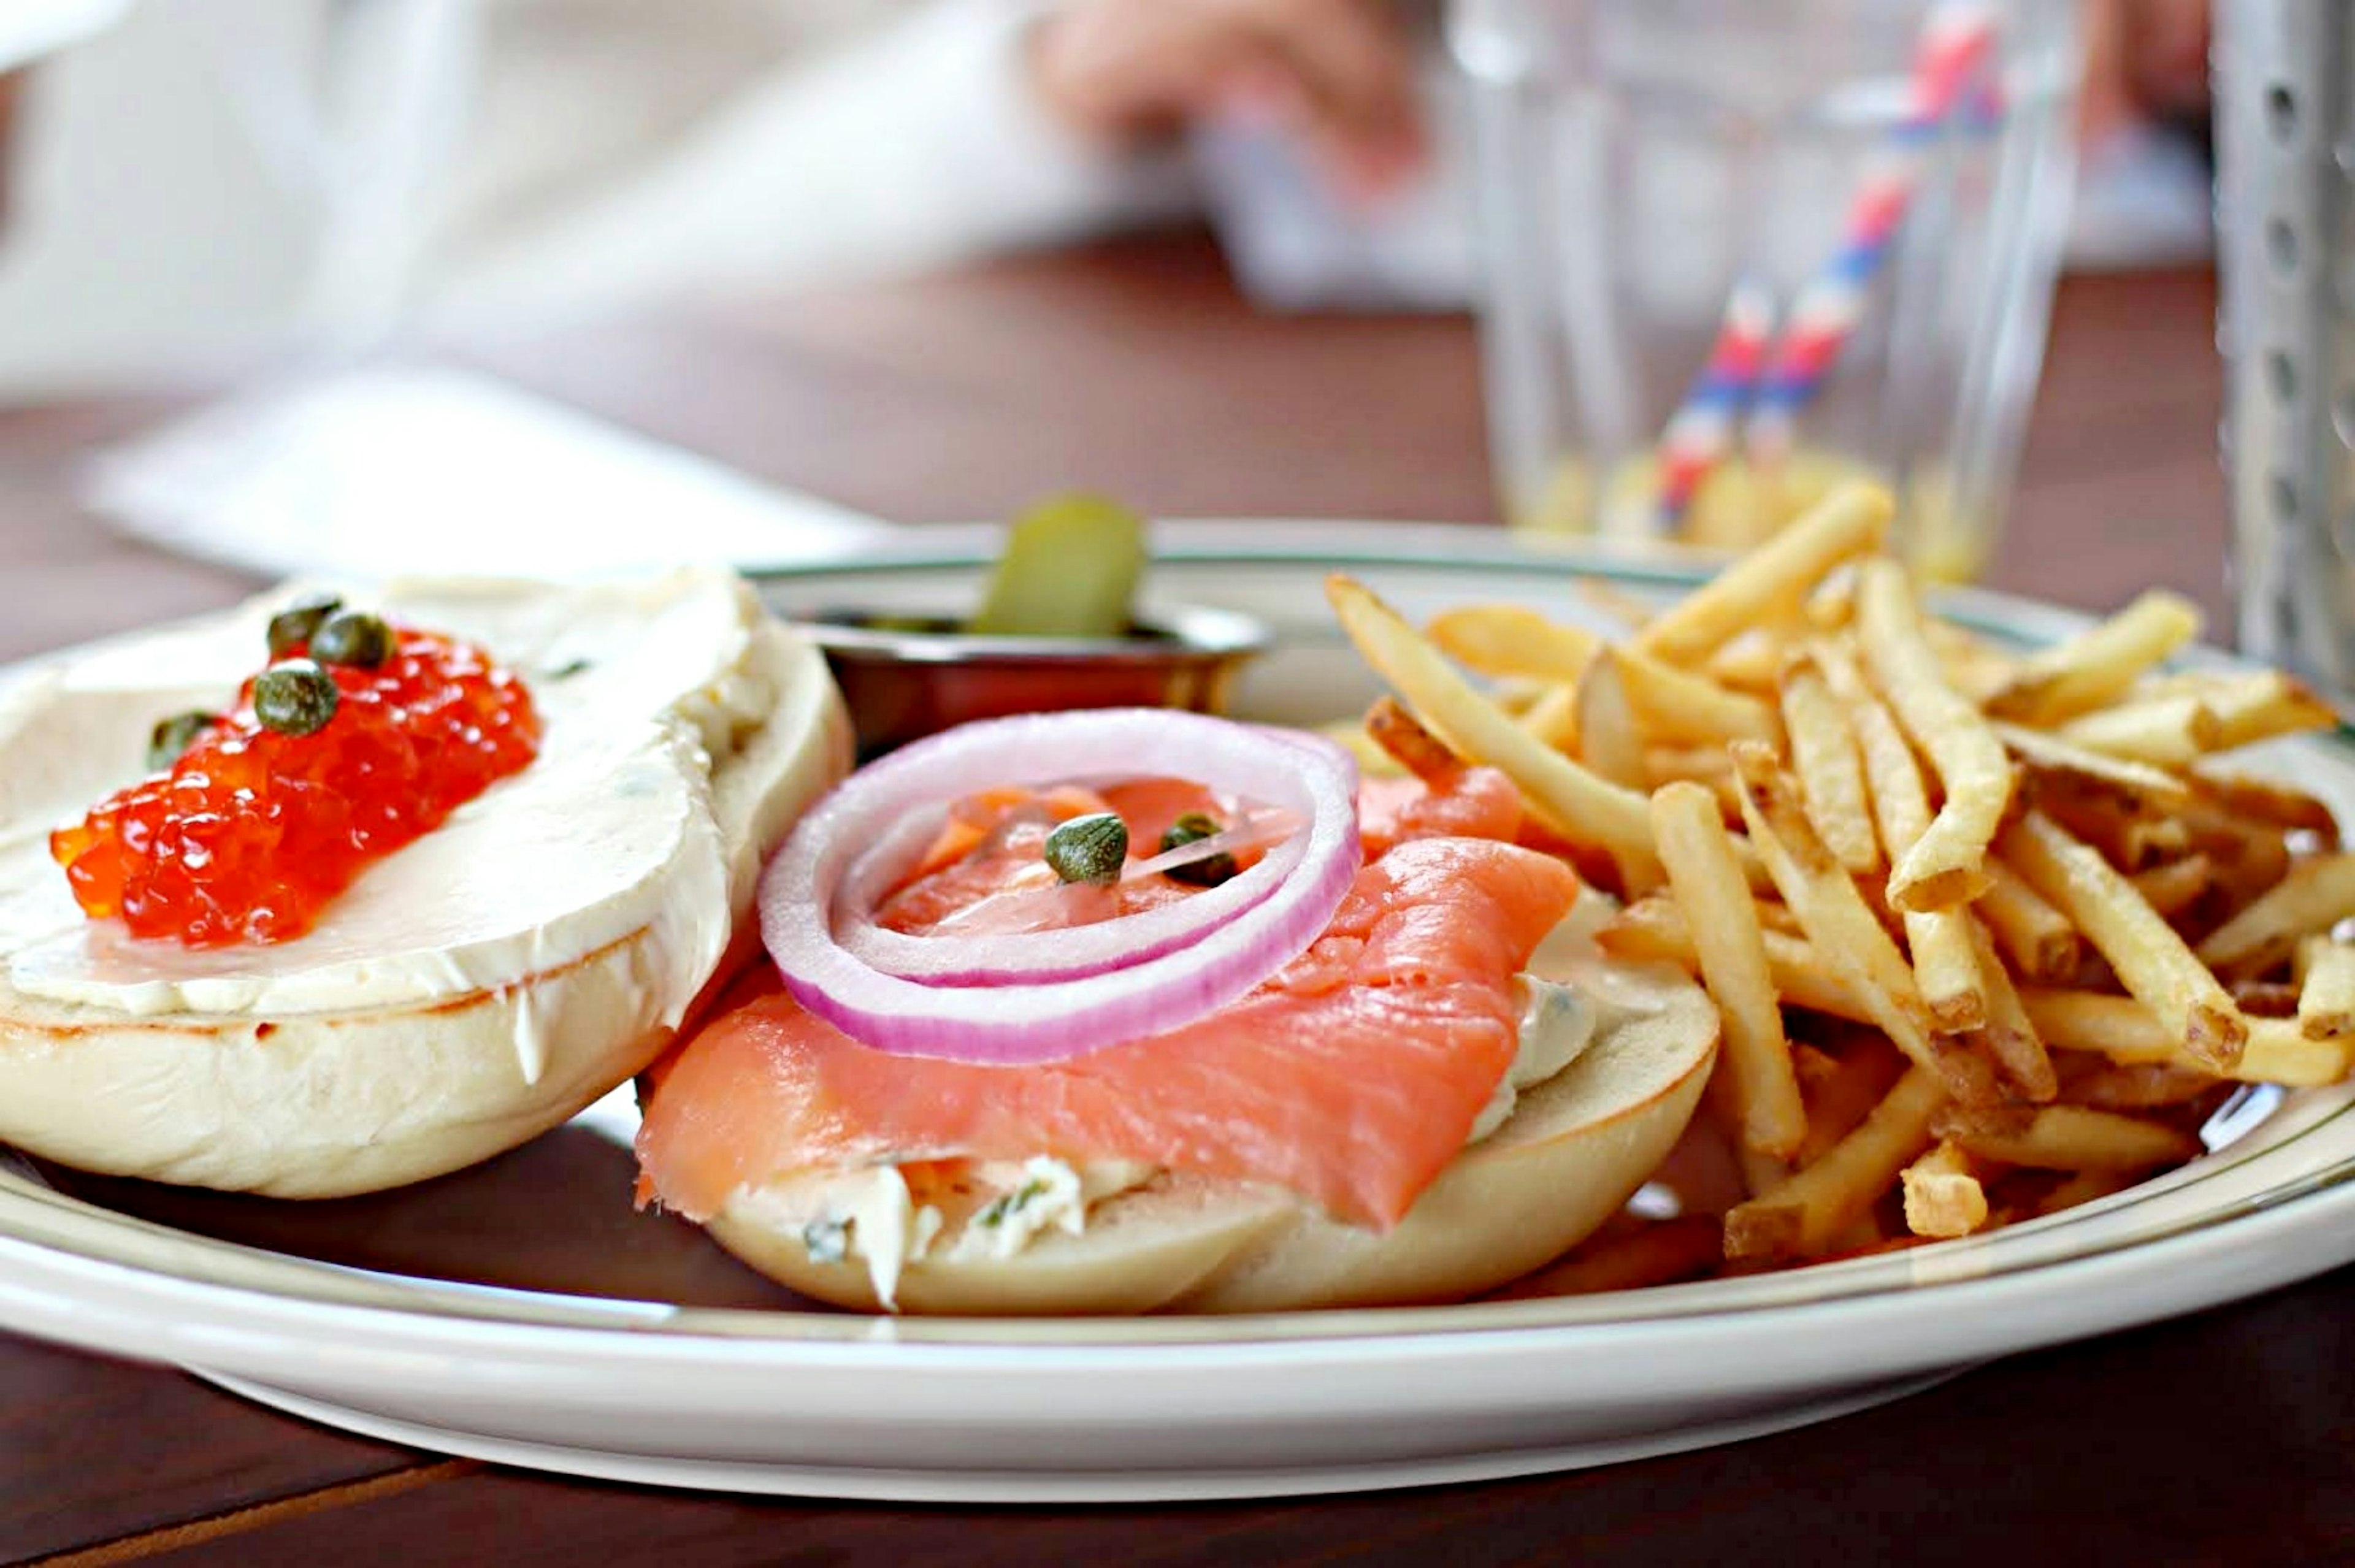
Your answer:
[1745,0,2002,464]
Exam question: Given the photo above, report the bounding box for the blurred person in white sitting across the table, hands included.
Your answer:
[0,0,2207,391]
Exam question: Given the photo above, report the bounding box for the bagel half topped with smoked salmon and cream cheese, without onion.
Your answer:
[638,721,1719,1316]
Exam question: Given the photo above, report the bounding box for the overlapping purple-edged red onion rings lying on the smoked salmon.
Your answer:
[760,709,1359,1062]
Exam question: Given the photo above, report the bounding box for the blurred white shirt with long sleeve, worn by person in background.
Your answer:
[0,0,1182,393]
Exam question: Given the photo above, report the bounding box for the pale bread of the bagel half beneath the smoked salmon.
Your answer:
[709,951,1719,1316]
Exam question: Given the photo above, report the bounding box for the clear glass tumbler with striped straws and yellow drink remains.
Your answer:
[1449,0,2080,579]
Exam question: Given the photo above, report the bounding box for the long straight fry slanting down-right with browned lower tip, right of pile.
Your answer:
[2002,813,2249,1071]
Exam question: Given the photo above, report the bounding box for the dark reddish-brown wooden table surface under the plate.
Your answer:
[0,235,2355,1568]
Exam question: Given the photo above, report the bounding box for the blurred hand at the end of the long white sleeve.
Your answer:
[1029,0,1427,200]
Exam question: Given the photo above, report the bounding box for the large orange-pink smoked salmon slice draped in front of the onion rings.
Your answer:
[638,819,1578,1226]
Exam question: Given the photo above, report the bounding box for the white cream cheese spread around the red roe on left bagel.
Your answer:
[0,570,772,1036]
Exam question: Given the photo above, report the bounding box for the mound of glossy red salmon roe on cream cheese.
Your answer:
[50,629,539,946]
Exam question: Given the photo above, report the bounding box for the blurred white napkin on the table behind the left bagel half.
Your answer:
[82,367,892,577]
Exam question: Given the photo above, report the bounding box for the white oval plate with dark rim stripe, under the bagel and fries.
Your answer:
[0,522,2355,1502]
